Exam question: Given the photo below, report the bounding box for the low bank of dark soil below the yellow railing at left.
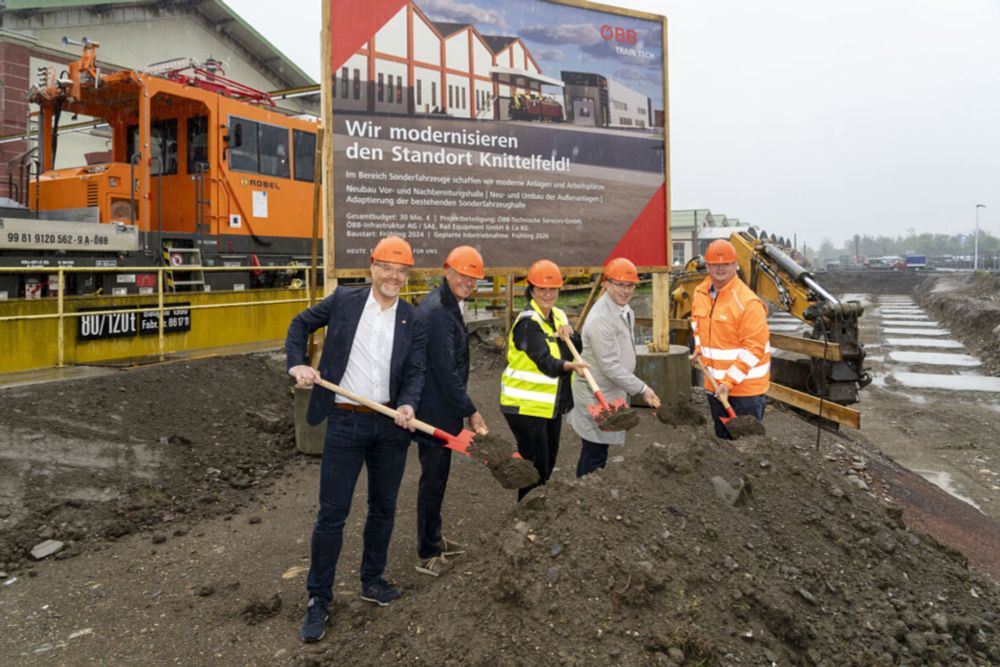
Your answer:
[0,354,295,572]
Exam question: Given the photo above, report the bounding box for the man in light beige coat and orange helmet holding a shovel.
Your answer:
[569,257,660,477]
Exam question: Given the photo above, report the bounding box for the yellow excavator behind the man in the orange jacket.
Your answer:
[670,232,871,428]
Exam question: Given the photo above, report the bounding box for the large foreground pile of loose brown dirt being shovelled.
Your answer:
[298,427,1000,665]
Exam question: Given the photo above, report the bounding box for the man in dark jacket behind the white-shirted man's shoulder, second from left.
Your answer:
[416,246,486,577]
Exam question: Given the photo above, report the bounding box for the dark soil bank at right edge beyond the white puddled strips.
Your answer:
[917,274,1000,375]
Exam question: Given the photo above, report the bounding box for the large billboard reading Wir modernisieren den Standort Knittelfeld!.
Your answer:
[325,0,668,271]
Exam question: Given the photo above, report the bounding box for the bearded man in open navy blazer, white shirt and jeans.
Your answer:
[285,236,426,642]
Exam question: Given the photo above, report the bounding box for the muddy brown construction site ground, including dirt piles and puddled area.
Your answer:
[0,274,1000,665]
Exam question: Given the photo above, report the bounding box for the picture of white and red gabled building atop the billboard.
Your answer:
[331,2,663,129]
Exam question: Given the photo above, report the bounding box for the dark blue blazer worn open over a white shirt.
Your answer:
[285,287,427,424]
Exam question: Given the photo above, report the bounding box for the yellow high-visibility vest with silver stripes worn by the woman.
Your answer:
[500,300,569,419]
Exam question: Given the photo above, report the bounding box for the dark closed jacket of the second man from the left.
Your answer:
[416,281,476,445]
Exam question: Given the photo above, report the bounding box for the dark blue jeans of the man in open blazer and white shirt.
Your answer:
[306,408,410,601]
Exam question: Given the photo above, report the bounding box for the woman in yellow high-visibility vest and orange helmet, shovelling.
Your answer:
[500,259,587,500]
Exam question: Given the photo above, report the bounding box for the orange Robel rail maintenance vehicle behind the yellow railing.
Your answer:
[0,41,318,297]
